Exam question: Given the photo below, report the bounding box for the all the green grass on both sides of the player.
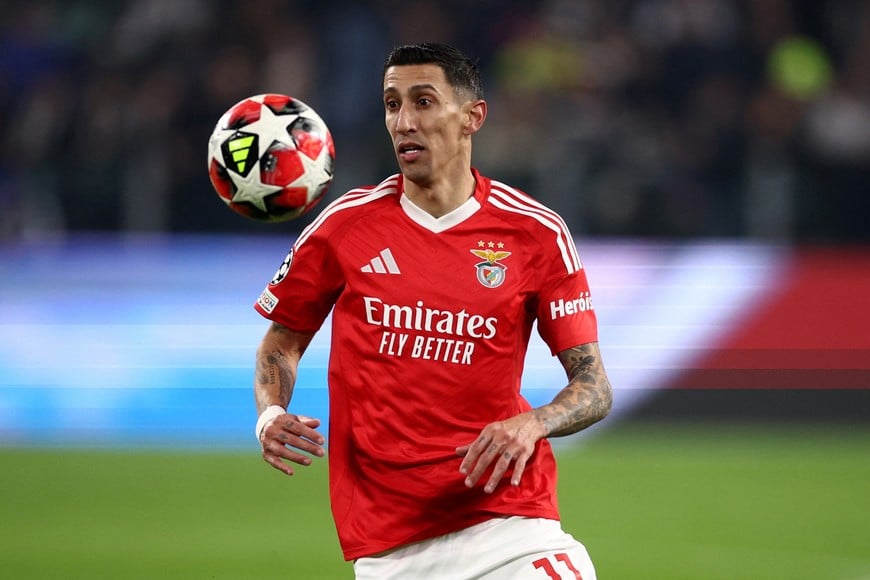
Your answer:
[0,425,870,580]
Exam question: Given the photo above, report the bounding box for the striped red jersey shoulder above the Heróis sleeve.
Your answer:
[487,179,583,274]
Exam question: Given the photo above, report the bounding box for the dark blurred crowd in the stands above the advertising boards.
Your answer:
[0,0,870,243]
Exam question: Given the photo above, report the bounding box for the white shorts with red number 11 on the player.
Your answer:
[353,517,595,580]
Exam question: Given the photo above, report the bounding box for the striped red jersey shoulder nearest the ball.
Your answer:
[296,174,399,247]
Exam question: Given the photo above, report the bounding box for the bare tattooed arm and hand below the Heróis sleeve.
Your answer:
[456,342,613,493]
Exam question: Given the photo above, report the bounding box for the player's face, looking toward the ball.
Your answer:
[384,64,472,187]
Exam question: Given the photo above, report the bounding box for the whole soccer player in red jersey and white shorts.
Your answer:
[255,44,612,580]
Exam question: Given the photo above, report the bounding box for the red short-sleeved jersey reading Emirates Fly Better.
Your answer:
[255,170,597,560]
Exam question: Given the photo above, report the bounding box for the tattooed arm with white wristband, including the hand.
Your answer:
[254,322,324,475]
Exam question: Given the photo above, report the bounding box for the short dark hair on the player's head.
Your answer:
[384,42,483,99]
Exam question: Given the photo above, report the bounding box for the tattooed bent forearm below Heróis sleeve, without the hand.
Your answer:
[536,343,613,437]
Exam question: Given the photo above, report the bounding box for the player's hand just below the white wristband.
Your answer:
[260,413,324,475]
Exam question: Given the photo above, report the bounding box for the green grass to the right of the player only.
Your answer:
[560,425,870,580]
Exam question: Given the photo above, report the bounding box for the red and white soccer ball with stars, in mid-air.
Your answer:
[208,94,335,222]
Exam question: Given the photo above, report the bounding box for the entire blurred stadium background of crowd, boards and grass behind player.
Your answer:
[0,0,870,579]
